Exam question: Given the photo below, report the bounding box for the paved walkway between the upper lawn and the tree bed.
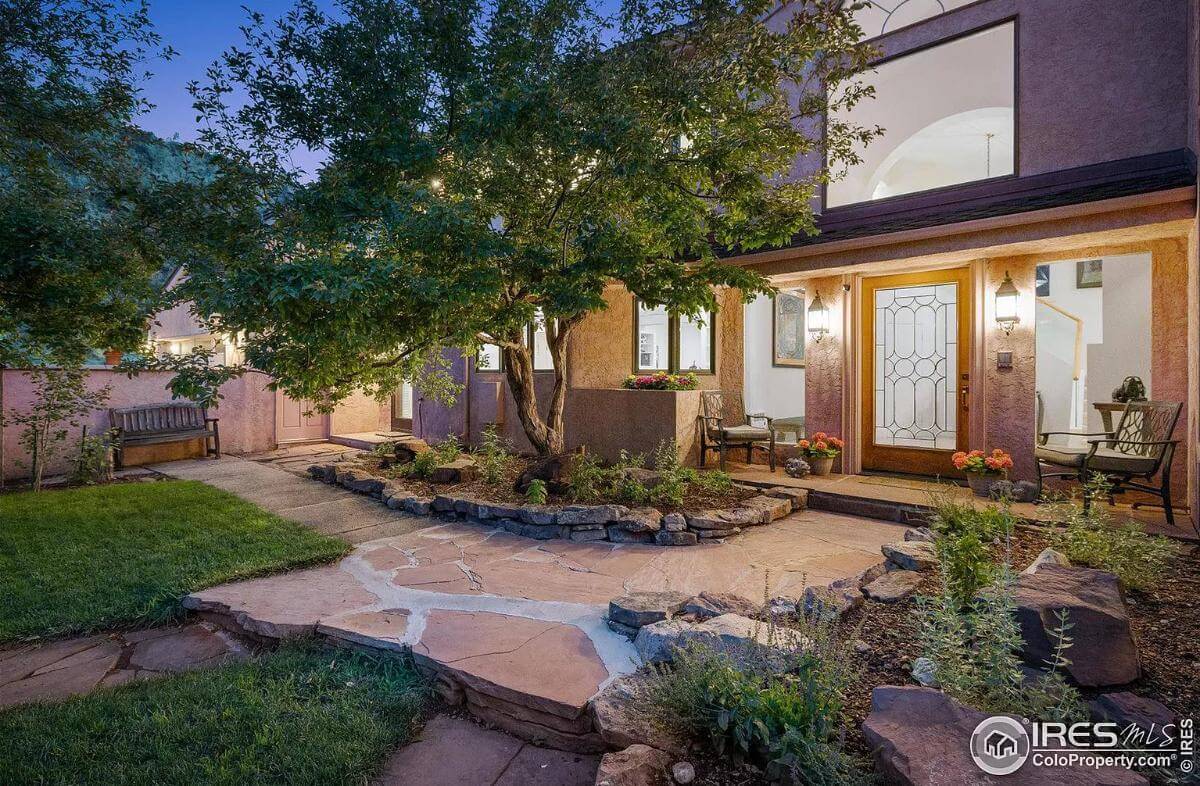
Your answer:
[151,445,431,544]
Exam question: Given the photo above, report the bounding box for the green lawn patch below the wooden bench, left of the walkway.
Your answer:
[0,481,349,642]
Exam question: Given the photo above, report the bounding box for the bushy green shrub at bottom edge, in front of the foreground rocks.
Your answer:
[638,622,866,784]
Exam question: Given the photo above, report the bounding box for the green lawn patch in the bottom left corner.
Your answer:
[0,644,427,786]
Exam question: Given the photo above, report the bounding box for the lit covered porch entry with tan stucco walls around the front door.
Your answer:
[739,190,1200,534]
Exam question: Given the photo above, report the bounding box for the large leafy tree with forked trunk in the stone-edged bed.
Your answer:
[182,0,875,454]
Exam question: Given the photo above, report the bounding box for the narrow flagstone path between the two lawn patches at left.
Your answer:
[0,623,251,707]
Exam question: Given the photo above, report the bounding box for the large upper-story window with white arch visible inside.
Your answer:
[826,22,1016,208]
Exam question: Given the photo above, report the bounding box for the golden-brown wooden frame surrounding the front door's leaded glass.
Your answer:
[847,266,976,475]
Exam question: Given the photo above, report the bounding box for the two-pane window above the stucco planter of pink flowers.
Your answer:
[634,302,715,373]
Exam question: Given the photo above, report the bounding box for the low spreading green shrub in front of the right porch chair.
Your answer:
[1050,475,1176,589]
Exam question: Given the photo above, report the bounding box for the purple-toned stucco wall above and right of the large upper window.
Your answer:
[816,0,1195,182]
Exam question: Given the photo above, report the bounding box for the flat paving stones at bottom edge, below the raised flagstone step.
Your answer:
[377,715,599,786]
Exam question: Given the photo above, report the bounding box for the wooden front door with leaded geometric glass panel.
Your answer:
[862,268,971,475]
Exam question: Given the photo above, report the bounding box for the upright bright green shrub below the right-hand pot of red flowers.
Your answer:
[929,494,1014,607]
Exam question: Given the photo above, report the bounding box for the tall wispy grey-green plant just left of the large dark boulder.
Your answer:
[917,565,1087,721]
